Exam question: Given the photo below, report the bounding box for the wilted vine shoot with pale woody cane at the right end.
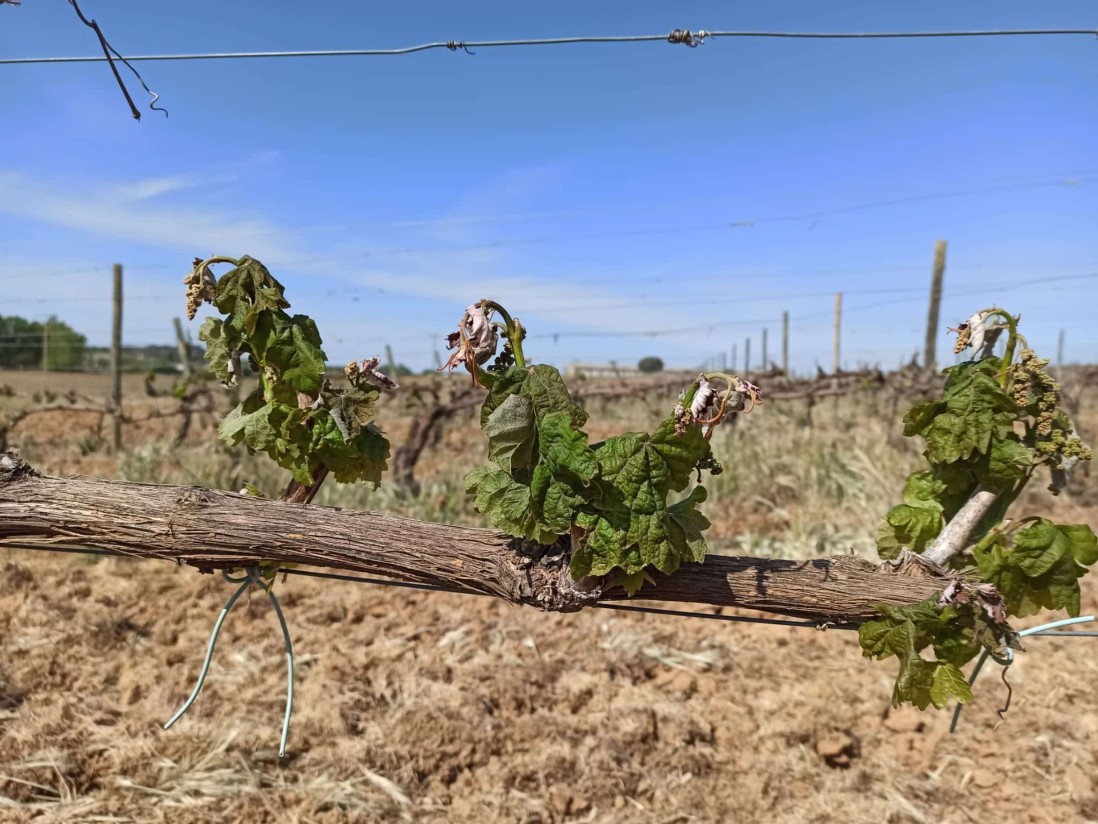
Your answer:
[860,308,1098,709]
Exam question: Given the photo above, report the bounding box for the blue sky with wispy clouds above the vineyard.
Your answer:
[0,0,1098,369]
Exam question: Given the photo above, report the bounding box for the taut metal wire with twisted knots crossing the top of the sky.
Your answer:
[0,29,1098,65]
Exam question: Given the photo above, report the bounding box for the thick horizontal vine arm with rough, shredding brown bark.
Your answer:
[0,453,949,625]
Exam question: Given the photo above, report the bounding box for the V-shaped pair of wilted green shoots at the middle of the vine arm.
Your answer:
[444,300,762,594]
